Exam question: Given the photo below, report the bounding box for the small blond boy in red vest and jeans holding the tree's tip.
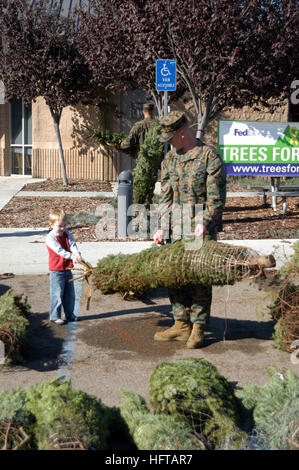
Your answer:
[46,209,83,325]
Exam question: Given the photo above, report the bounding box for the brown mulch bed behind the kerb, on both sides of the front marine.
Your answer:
[0,180,299,242]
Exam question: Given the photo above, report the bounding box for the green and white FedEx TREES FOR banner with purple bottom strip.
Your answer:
[218,121,299,177]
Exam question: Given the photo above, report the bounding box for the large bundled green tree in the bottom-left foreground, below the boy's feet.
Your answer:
[25,377,108,450]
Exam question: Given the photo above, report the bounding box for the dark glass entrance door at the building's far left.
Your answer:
[10,100,32,175]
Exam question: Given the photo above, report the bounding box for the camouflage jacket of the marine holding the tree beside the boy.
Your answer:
[161,141,226,234]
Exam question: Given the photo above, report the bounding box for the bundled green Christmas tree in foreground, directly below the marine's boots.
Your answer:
[150,358,246,449]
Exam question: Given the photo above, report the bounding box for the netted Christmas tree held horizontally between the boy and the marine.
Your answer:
[89,240,275,295]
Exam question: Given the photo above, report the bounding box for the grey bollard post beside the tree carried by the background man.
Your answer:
[117,170,133,238]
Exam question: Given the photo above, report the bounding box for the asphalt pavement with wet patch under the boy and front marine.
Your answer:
[0,275,299,406]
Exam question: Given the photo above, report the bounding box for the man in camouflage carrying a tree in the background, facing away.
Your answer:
[119,103,158,159]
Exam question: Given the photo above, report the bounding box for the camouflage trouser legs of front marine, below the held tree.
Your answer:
[168,233,217,325]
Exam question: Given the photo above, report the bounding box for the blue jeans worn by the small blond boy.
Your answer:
[50,271,82,321]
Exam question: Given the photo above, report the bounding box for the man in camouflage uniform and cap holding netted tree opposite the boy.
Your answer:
[155,111,226,347]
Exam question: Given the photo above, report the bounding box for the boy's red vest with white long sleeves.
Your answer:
[46,230,81,271]
